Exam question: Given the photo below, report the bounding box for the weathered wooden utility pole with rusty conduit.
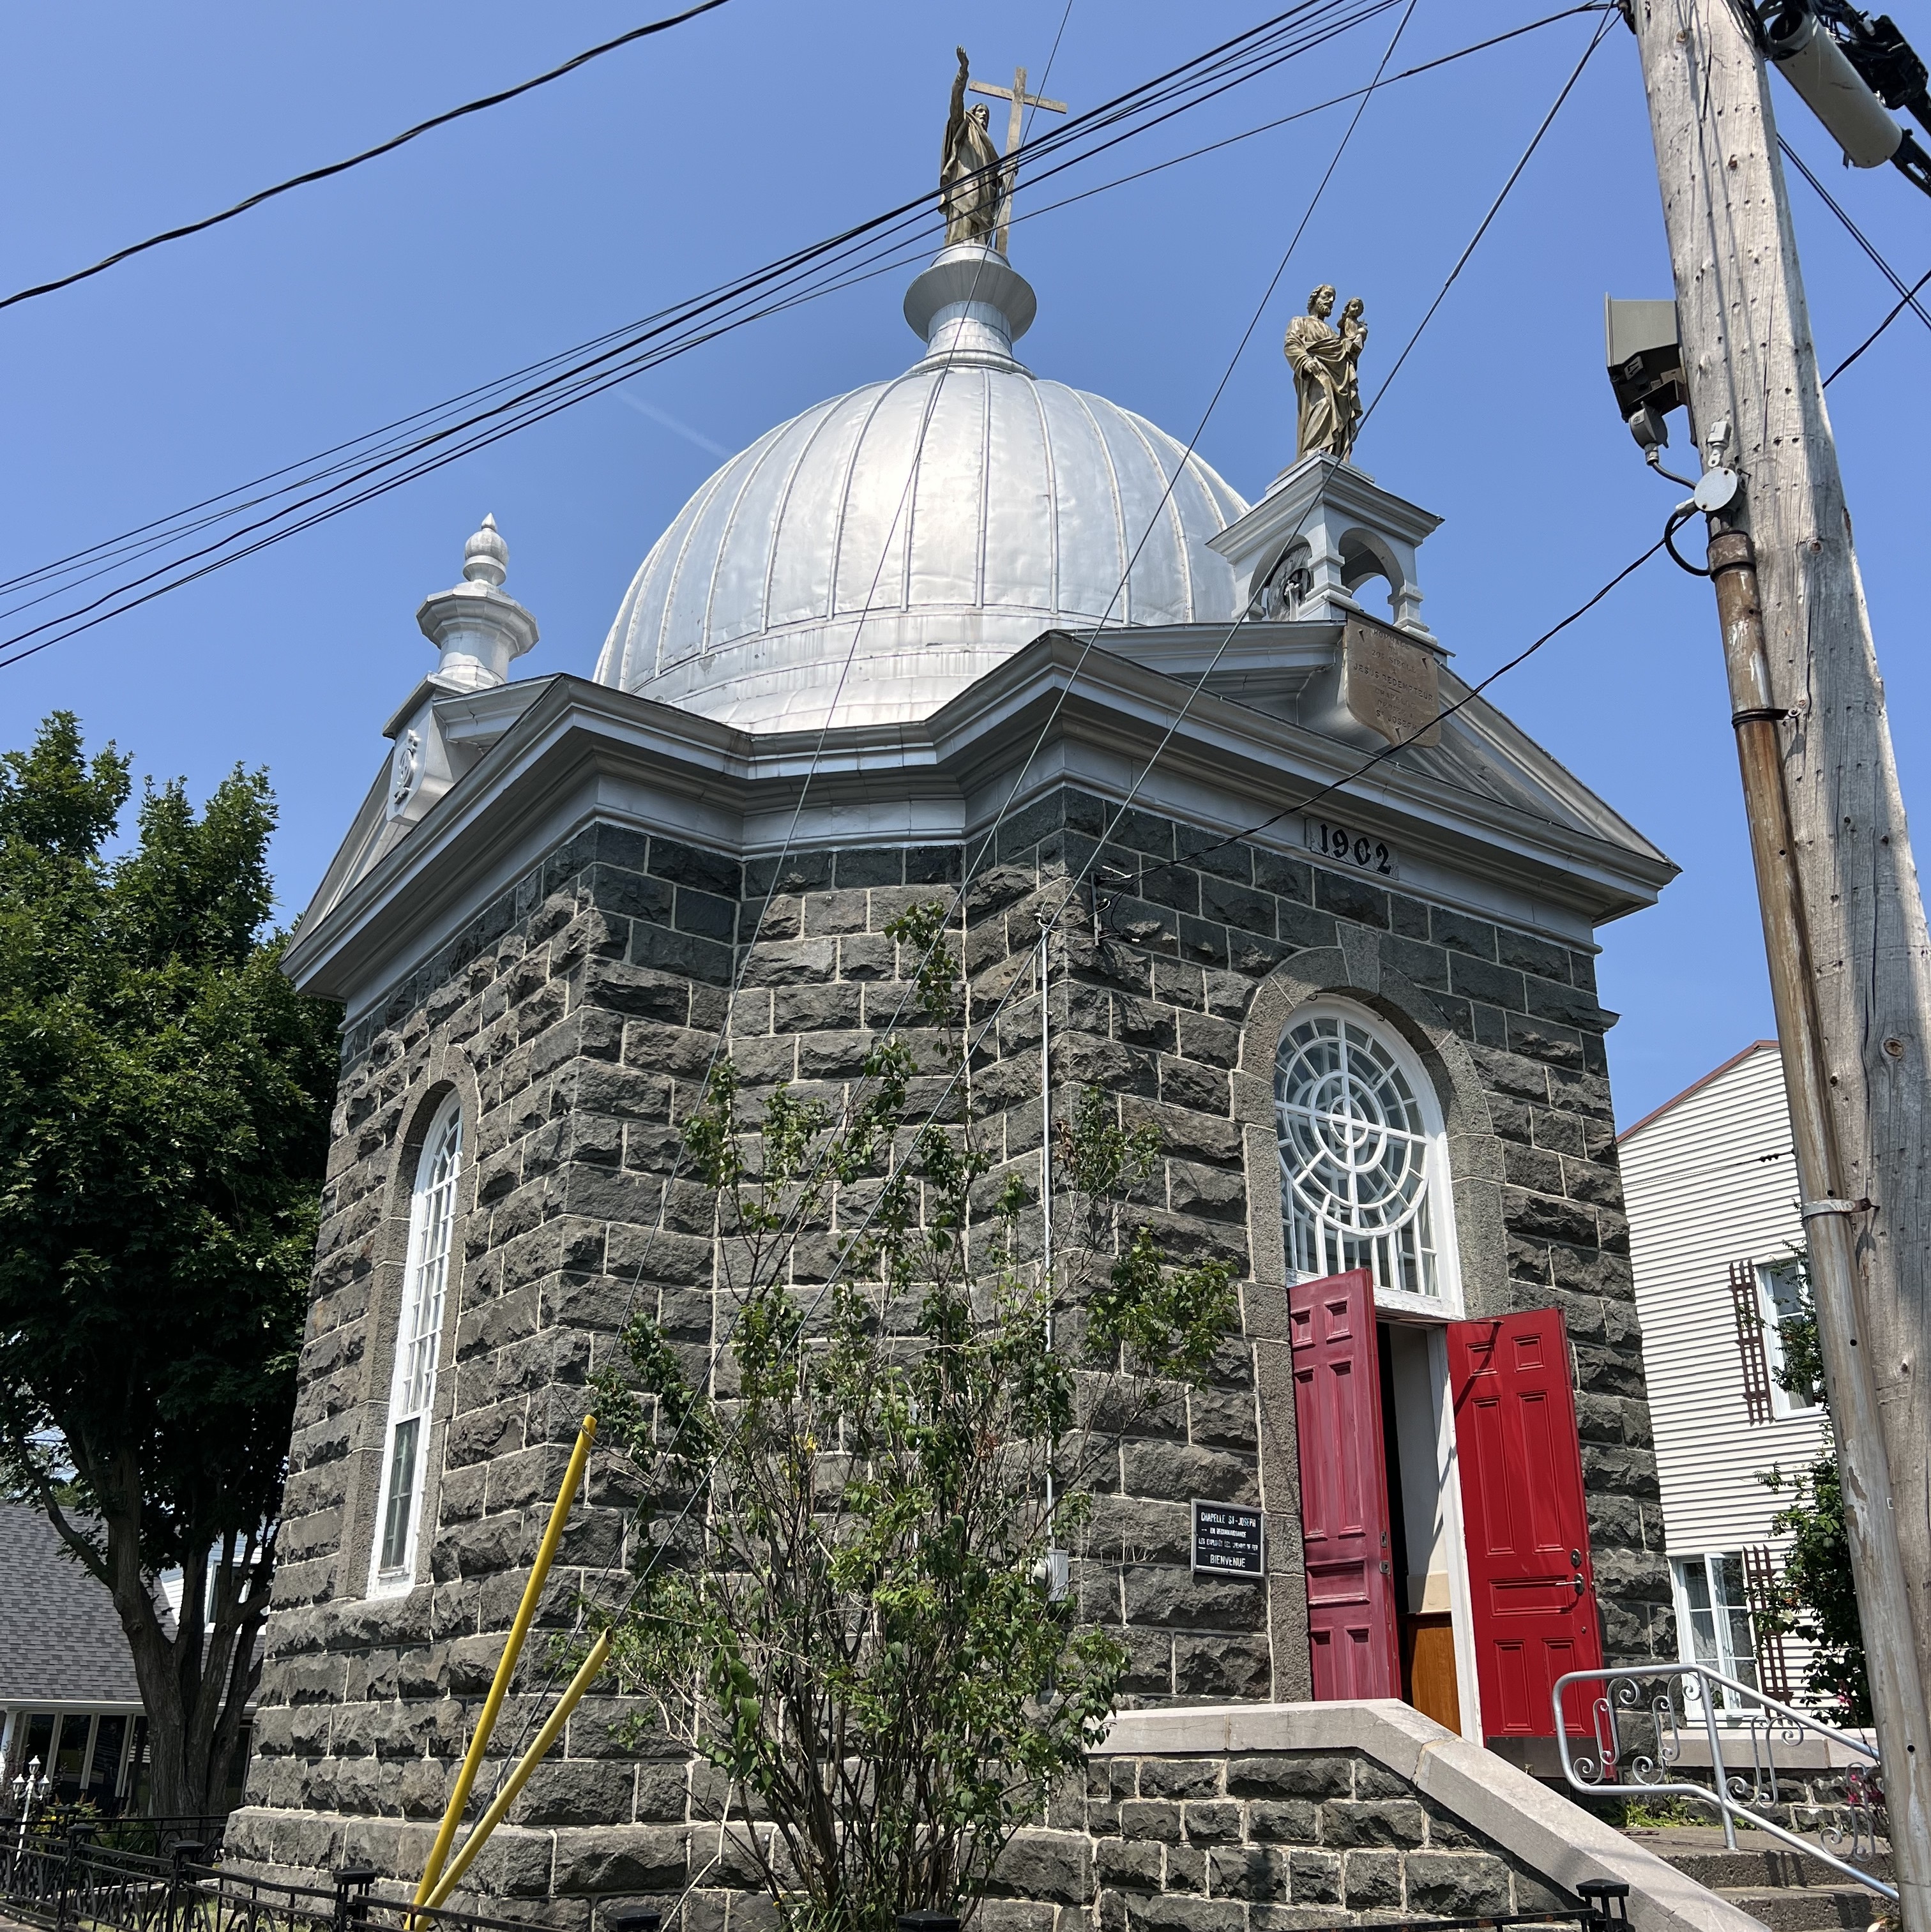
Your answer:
[1624,0,1931,1932]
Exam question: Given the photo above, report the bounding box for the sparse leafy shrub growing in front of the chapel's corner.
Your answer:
[599,906,1235,1932]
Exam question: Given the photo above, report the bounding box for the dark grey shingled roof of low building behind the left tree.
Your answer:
[0,1503,141,1704]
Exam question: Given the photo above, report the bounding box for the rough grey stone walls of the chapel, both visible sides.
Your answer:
[230,776,1672,1893]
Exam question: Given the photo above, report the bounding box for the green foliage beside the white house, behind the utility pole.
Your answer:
[1759,1252,1871,1723]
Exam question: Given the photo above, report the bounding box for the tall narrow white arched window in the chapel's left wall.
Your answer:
[369,1096,462,1596]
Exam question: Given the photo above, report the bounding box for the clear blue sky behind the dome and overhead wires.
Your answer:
[0,0,1931,1121]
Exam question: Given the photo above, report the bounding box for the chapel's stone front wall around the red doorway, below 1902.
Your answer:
[969,790,1676,1698]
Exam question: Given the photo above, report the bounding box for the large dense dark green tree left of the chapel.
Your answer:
[0,713,337,1814]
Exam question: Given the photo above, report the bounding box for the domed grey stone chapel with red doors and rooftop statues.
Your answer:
[228,45,1674,1916]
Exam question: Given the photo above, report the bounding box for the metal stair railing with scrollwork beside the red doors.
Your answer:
[1554,1663,1898,1899]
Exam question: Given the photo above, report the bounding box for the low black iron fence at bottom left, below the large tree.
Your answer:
[0,1834,538,1932]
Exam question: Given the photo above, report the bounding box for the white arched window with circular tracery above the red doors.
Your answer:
[1274,1000,1457,1306]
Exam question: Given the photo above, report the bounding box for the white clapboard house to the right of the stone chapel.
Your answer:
[1620,1039,1825,1704]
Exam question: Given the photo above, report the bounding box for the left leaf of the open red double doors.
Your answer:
[1287,1267,1402,1700]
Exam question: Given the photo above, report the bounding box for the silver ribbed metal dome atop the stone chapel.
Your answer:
[595,245,1246,730]
